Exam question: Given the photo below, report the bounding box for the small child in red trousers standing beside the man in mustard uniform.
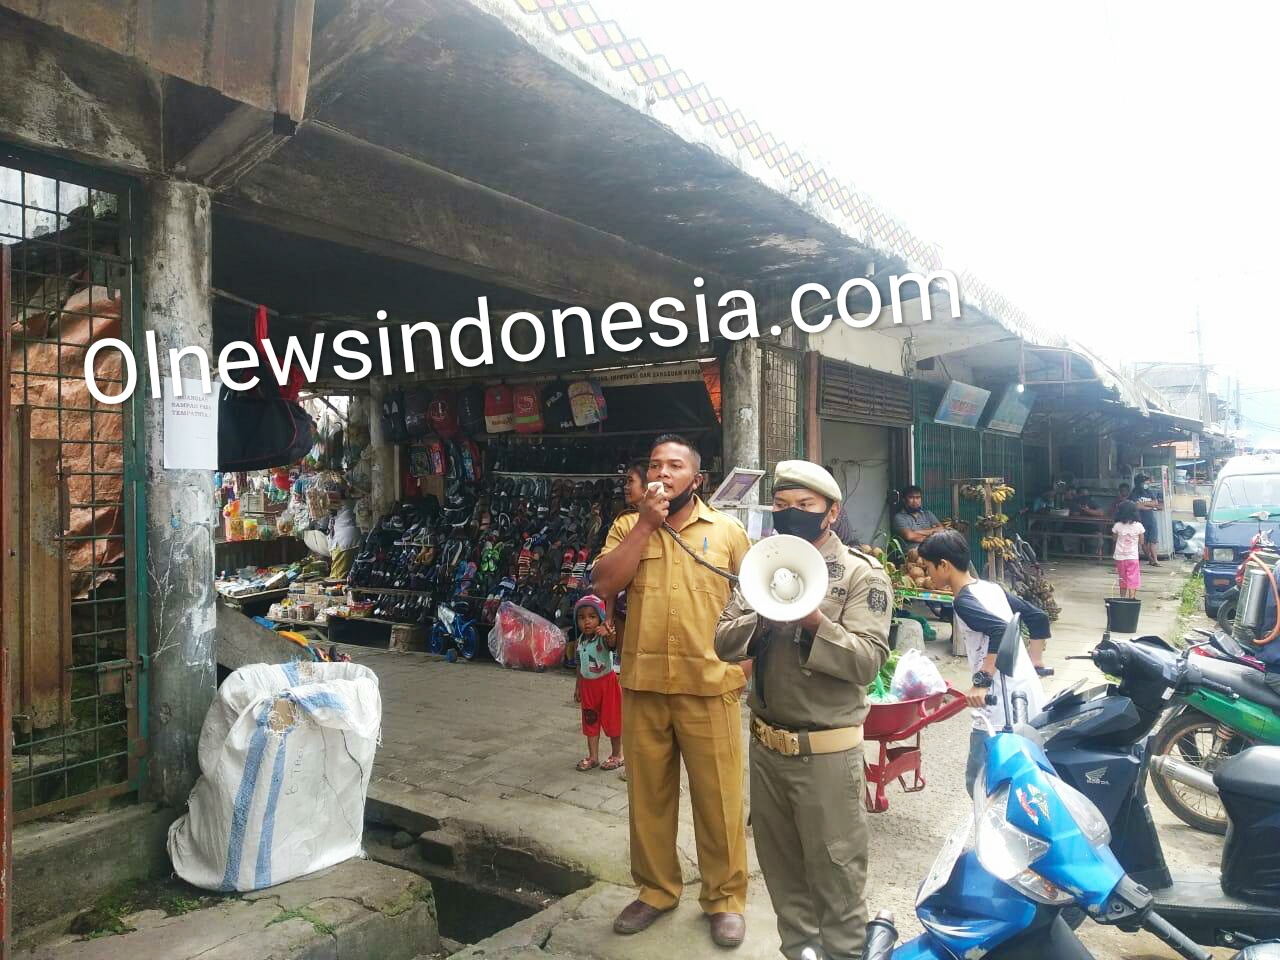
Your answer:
[573,594,622,772]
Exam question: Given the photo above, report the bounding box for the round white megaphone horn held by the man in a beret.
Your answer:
[737,534,829,623]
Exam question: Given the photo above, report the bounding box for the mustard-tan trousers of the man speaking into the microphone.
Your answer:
[622,690,748,914]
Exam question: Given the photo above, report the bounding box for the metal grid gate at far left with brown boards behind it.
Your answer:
[0,150,146,820]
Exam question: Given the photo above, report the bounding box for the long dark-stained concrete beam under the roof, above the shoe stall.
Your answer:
[225,123,732,308]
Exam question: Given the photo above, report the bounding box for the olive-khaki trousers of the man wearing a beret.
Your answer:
[747,740,868,960]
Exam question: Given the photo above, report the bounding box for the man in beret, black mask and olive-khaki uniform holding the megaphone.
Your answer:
[716,460,893,960]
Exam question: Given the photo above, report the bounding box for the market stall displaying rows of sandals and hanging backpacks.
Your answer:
[340,362,723,658]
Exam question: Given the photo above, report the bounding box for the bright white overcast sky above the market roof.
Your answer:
[595,0,1280,443]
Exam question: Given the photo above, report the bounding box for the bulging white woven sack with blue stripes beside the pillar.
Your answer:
[169,663,383,892]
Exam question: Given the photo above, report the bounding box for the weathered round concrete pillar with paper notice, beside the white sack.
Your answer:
[138,180,219,806]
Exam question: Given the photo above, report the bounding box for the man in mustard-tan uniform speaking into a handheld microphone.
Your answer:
[591,436,749,947]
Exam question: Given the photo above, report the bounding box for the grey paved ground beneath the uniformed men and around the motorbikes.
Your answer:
[348,552,1221,960]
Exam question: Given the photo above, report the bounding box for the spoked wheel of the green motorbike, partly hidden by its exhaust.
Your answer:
[1151,710,1251,835]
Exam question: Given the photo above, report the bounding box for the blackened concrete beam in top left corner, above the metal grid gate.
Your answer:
[0,8,164,173]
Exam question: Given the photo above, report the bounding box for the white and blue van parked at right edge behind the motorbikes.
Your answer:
[1196,453,1280,617]
